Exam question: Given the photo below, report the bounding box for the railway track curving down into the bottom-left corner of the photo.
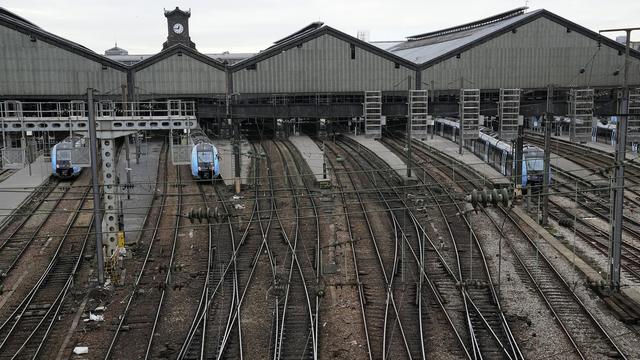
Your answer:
[0,183,93,359]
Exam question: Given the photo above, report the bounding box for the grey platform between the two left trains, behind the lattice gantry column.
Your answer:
[117,138,163,244]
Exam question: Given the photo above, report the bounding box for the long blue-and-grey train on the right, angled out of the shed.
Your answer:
[435,119,551,188]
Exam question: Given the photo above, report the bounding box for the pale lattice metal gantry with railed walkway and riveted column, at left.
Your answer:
[0,98,197,268]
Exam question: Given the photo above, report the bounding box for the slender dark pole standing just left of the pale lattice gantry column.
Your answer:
[87,89,104,285]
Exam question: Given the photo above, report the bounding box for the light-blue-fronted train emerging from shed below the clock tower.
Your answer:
[189,129,220,180]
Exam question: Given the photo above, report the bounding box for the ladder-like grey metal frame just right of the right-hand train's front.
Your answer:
[569,89,593,143]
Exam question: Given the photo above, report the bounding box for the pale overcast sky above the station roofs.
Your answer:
[0,0,640,54]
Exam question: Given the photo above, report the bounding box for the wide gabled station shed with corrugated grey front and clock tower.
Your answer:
[0,8,640,135]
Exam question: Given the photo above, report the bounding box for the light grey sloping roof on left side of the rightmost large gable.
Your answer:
[388,9,543,64]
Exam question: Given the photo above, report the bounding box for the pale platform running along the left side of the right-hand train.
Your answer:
[419,135,511,188]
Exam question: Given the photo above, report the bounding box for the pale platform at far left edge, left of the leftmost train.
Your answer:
[0,156,51,224]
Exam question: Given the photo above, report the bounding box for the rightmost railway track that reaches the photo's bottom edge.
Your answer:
[414,134,626,359]
